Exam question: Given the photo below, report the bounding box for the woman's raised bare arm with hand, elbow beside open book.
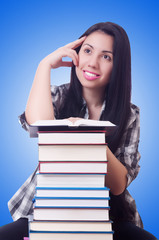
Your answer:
[25,37,85,124]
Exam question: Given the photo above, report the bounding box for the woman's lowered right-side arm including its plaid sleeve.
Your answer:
[106,104,140,195]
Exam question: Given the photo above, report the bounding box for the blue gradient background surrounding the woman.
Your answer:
[0,0,159,238]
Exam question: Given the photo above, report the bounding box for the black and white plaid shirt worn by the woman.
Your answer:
[8,84,143,227]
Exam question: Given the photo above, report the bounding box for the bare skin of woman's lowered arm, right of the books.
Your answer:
[106,147,128,195]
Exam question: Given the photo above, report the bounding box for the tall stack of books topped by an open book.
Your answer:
[29,120,114,240]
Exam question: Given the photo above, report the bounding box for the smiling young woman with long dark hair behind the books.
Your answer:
[0,22,156,240]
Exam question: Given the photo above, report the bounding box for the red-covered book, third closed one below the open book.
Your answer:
[39,161,107,173]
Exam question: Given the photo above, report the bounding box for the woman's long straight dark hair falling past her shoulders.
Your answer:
[59,22,131,152]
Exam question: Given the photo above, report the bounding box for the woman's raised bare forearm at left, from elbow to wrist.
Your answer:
[25,61,54,124]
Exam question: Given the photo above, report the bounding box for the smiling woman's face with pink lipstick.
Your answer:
[76,31,113,89]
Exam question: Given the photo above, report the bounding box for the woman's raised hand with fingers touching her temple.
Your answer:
[42,36,86,68]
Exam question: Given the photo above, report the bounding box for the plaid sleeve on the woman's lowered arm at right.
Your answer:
[115,104,140,186]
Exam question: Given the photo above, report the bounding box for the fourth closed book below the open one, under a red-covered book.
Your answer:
[37,174,105,188]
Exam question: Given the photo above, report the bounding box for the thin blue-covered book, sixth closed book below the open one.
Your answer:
[35,196,109,207]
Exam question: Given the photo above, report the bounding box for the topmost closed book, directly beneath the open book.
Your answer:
[38,131,105,144]
